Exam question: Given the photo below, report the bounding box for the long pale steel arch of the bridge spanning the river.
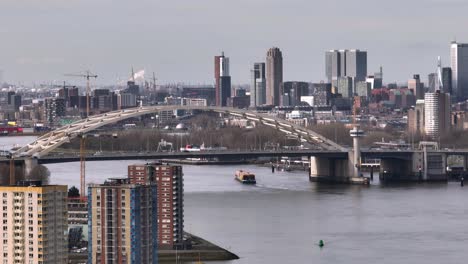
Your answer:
[12,106,348,158]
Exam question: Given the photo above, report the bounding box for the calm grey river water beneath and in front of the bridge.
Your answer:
[0,137,468,264]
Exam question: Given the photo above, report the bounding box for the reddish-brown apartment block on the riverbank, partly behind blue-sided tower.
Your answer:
[128,164,184,249]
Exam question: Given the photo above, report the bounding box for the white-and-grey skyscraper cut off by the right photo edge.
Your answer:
[450,41,468,101]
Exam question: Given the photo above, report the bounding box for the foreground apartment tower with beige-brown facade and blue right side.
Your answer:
[88,179,158,264]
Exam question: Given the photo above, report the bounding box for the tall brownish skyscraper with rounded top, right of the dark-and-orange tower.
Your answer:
[266,47,283,105]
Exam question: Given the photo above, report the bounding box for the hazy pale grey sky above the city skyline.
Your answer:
[0,0,468,84]
